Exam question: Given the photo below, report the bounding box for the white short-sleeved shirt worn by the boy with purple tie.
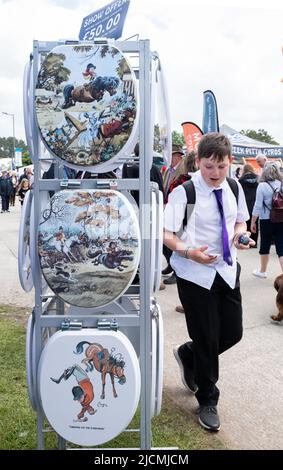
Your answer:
[164,171,250,289]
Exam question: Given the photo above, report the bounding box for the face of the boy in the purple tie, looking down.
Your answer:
[196,155,232,188]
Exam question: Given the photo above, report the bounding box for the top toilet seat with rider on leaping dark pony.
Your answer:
[34,43,138,173]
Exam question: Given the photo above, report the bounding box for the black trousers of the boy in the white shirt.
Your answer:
[177,264,243,406]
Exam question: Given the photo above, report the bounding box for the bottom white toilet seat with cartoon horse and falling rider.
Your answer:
[39,329,140,446]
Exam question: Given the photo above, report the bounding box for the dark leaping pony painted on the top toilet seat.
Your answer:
[62,77,119,109]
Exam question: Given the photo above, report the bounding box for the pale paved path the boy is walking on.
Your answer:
[0,202,283,449]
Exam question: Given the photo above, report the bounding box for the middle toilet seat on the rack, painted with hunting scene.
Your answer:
[38,189,140,308]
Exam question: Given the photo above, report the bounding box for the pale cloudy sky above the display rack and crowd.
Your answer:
[0,0,283,145]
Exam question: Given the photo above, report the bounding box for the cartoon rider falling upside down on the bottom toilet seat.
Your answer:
[50,364,97,421]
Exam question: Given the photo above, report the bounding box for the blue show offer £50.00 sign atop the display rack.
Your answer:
[79,0,130,41]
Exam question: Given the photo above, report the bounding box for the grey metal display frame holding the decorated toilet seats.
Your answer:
[28,40,162,450]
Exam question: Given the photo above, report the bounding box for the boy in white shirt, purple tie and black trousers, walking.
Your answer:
[164,132,254,431]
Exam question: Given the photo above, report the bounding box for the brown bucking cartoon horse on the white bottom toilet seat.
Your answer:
[74,341,126,400]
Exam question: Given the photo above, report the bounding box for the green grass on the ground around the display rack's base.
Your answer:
[0,305,224,450]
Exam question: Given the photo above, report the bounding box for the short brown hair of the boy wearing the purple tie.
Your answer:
[197,132,232,161]
